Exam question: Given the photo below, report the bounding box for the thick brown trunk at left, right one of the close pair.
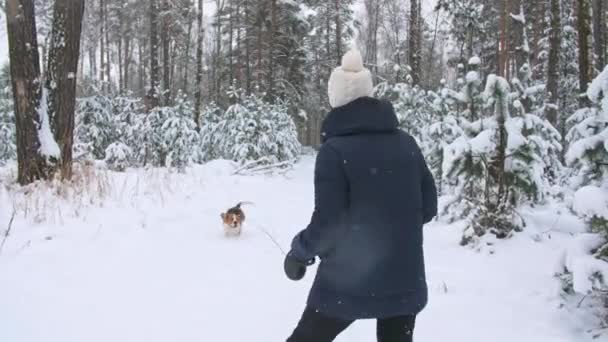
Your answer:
[47,0,84,179]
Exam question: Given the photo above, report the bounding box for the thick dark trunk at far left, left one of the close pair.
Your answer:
[6,0,50,185]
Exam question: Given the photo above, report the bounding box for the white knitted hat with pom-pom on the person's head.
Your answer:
[327,49,374,108]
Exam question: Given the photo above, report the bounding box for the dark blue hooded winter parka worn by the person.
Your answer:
[292,97,437,319]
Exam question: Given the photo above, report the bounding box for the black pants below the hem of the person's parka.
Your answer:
[287,308,416,342]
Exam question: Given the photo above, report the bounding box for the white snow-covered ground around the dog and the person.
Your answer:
[0,156,608,342]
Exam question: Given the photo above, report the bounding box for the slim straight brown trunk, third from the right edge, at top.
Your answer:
[545,0,562,127]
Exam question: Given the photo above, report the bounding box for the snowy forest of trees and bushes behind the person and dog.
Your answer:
[0,0,608,338]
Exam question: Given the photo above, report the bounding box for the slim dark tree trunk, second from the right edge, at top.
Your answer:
[577,0,592,99]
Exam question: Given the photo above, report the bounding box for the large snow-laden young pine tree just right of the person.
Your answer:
[442,55,562,244]
